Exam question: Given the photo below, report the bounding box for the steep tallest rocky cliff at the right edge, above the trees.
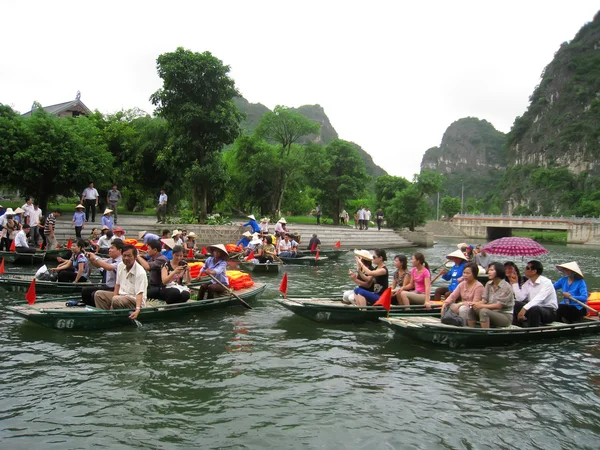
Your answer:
[507,13,600,174]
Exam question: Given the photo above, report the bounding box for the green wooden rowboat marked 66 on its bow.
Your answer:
[7,283,266,331]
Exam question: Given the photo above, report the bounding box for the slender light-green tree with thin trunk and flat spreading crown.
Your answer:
[255,106,320,214]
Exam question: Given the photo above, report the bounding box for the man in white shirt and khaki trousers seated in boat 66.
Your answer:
[95,245,148,319]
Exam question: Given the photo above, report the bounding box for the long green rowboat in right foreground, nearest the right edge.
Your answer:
[379,317,600,348]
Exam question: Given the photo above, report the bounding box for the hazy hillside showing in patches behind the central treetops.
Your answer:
[235,97,387,177]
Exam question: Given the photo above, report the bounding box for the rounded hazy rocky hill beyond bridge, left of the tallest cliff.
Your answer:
[421,117,506,197]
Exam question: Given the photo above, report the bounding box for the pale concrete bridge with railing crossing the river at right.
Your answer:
[452,214,600,245]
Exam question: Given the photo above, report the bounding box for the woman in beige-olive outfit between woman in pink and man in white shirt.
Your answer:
[467,262,515,328]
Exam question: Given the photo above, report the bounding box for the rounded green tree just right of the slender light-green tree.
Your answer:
[310,139,369,224]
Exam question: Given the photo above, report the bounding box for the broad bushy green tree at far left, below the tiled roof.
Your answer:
[0,104,113,210]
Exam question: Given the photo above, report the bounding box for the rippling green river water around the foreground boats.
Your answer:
[0,237,600,449]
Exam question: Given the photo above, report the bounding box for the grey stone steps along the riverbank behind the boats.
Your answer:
[51,216,414,249]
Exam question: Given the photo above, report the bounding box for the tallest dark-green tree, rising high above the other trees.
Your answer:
[150,47,243,220]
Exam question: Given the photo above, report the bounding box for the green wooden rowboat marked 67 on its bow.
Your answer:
[275,298,442,323]
